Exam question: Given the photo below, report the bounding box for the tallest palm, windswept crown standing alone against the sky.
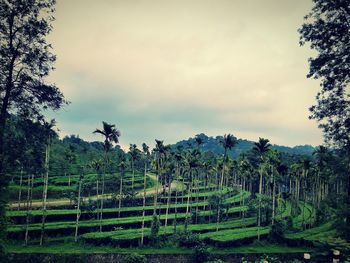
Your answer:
[93,121,120,232]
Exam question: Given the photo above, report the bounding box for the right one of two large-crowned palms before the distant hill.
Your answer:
[253,138,271,240]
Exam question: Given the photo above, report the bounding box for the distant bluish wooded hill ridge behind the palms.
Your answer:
[174,133,315,158]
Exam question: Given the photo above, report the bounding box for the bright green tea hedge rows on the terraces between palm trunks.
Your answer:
[7,173,327,254]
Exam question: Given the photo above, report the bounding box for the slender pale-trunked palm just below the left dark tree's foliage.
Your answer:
[40,120,57,246]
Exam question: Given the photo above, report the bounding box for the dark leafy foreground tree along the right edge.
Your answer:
[299,0,350,239]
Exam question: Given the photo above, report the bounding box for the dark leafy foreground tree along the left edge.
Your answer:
[0,0,65,254]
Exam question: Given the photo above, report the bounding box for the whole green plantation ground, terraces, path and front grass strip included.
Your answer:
[6,164,344,262]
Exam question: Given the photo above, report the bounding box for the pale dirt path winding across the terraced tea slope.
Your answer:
[9,174,183,208]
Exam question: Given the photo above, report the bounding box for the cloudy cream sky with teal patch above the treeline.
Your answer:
[48,0,322,148]
